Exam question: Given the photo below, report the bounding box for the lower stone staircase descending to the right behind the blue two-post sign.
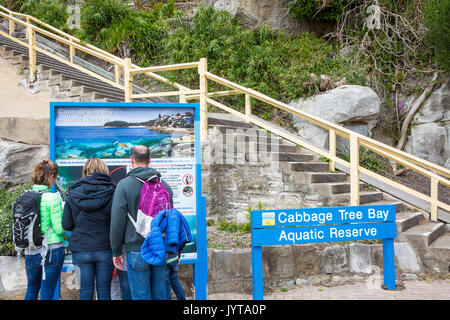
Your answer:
[208,118,450,273]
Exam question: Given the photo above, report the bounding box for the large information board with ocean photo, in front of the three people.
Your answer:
[52,104,197,259]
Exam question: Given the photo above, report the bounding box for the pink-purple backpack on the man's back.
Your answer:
[128,176,172,238]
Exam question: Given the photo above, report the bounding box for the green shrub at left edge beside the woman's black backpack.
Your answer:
[0,183,31,256]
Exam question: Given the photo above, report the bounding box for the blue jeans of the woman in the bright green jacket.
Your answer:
[25,247,65,300]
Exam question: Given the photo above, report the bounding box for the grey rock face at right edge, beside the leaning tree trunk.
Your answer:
[405,83,450,168]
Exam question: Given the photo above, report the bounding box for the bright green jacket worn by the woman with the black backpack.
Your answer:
[32,184,64,244]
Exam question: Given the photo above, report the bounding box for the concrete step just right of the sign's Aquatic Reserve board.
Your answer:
[397,222,445,249]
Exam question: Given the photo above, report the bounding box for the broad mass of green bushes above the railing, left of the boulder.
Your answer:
[158,6,365,109]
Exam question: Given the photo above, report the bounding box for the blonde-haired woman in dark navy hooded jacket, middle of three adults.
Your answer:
[63,158,115,300]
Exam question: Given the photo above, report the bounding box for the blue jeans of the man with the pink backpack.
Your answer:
[127,251,167,300]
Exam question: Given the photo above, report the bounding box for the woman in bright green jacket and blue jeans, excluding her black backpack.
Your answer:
[25,160,64,300]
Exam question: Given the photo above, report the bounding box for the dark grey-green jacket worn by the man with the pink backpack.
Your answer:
[110,167,173,257]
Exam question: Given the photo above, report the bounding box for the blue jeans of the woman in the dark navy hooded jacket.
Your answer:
[72,250,114,300]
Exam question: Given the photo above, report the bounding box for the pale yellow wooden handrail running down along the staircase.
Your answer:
[0,6,450,221]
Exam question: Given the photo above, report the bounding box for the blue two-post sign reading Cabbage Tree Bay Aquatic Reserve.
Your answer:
[251,205,397,300]
